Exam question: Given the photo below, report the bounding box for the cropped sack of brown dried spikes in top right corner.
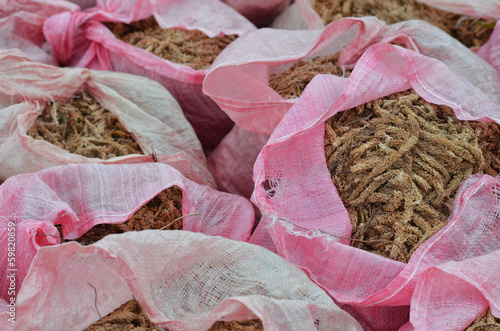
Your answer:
[273,0,498,48]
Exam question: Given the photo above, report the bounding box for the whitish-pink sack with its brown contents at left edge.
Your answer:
[0,51,215,186]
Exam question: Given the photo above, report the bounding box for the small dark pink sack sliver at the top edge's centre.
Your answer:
[223,0,291,27]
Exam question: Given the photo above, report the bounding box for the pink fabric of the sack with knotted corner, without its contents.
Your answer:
[44,0,255,153]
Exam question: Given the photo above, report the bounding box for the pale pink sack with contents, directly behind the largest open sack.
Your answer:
[203,17,500,196]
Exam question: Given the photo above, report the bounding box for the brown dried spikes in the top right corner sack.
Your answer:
[314,0,495,47]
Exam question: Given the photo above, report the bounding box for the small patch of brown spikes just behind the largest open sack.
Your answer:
[269,53,351,99]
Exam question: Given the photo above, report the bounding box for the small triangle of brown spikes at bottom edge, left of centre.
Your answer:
[84,299,162,331]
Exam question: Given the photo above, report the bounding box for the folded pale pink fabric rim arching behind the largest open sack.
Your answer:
[203,17,500,135]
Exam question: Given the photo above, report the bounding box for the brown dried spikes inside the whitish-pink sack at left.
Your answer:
[28,91,144,160]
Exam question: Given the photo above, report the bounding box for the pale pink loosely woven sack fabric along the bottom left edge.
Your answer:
[0,230,362,331]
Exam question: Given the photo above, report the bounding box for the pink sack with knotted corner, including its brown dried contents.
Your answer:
[44,0,255,154]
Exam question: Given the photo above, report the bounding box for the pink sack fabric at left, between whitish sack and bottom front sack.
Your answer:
[0,163,254,306]
